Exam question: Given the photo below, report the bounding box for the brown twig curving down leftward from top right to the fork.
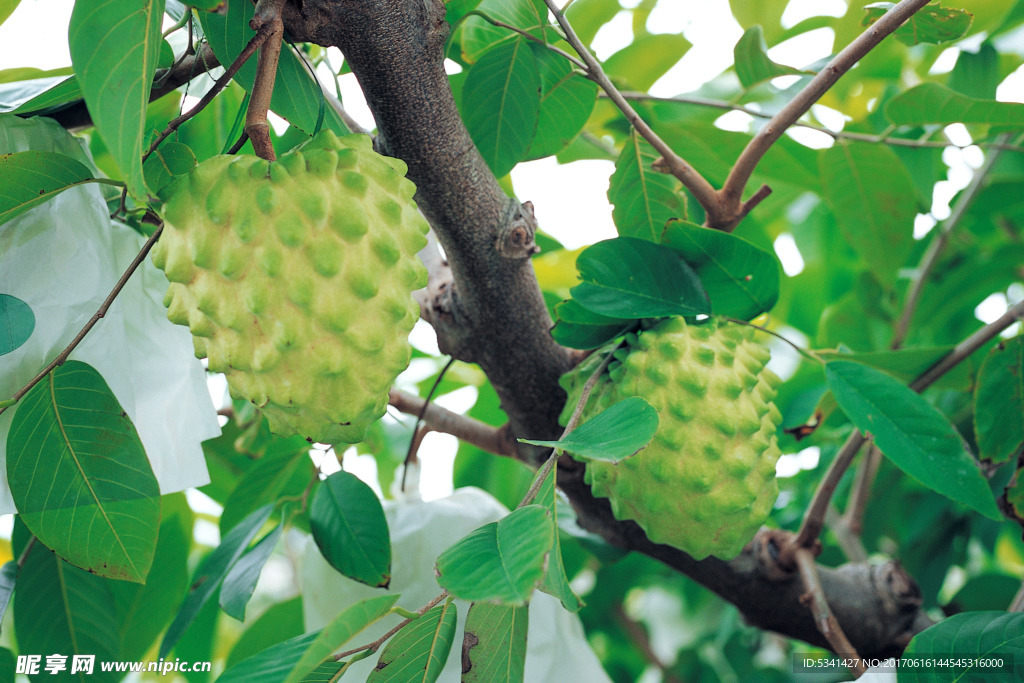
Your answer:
[720,0,931,229]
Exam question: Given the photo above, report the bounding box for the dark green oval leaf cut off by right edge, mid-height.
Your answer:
[974,337,1024,463]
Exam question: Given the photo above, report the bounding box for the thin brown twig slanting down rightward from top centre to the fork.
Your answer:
[544,0,720,216]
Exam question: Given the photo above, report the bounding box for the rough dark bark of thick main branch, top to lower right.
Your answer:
[286,0,928,656]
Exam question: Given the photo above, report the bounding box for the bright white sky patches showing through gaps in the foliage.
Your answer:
[0,0,1024,497]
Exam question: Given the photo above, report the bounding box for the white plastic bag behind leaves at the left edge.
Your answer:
[0,115,220,514]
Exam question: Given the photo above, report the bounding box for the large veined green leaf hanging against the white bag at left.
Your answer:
[7,360,160,583]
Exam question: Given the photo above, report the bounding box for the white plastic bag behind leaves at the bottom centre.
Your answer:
[301,487,610,683]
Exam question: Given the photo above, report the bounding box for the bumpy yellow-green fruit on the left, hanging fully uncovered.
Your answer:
[153,131,427,443]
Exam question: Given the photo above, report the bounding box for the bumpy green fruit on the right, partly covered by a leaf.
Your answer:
[562,317,781,559]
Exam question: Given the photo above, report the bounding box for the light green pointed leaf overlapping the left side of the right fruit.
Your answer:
[519,396,658,464]
